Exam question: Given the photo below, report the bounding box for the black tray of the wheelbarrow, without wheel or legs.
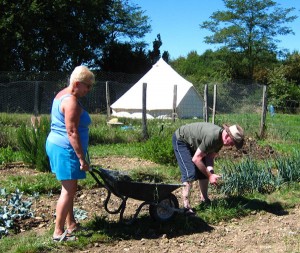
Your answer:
[98,168,182,202]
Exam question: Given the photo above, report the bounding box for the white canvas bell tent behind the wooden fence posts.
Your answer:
[111,58,203,118]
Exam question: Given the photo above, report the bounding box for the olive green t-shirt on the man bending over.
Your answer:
[175,122,223,154]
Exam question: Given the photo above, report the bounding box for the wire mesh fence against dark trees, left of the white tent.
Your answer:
[0,72,141,115]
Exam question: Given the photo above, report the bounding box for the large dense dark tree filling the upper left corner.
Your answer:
[0,0,110,71]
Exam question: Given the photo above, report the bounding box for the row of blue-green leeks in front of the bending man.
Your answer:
[219,151,300,196]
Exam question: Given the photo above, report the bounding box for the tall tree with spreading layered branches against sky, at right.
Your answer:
[200,0,297,79]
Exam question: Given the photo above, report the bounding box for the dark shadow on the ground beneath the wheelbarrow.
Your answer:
[88,214,213,240]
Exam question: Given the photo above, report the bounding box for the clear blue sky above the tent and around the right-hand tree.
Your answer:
[131,0,300,59]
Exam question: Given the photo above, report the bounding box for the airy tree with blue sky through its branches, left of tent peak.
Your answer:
[97,0,151,73]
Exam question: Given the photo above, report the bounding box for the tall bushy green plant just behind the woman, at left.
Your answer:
[17,117,50,172]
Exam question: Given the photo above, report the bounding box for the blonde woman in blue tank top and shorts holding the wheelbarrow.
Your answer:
[46,66,95,242]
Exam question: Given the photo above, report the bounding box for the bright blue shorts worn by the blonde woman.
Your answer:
[46,141,86,180]
